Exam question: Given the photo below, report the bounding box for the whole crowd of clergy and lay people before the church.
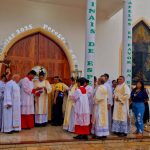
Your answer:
[0,70,149,140]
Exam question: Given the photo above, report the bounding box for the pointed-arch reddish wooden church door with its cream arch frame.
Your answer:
[0,28,74,83]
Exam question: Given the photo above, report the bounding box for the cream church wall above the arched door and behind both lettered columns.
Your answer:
[0,0,150,79]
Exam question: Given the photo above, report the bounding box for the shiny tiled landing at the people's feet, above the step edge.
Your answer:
[0,125,150,144]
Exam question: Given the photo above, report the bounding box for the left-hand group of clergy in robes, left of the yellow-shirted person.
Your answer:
[0,70,52,133]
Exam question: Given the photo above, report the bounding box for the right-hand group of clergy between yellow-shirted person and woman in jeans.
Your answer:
[63,74,130,140]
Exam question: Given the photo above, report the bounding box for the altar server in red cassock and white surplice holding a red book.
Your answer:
[20,70,36,129]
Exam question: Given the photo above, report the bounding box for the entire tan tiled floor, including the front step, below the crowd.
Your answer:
[0,125,150,150]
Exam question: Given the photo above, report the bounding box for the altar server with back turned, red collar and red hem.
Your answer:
[72,78,90,140]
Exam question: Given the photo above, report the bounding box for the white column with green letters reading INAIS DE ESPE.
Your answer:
[85,0,96,85]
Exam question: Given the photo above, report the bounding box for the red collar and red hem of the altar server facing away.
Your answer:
[75,87,90,135]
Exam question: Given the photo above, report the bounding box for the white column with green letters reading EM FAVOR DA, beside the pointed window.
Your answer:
[122,0,132,87]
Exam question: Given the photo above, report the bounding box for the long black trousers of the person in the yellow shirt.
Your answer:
[52,96,63,125]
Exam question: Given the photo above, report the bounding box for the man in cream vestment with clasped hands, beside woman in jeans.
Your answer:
[112,76,130,136]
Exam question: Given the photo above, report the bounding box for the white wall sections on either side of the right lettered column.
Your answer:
[96,0,150,79]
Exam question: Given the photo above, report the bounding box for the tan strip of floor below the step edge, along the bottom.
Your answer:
[0,142,150,150]
